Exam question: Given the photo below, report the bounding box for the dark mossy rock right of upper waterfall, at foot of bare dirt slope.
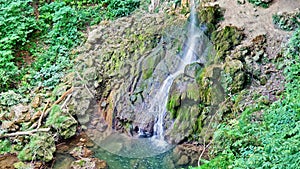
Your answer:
[211,26,244,62]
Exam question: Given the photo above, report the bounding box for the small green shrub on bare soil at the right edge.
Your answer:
[272,11,300,31]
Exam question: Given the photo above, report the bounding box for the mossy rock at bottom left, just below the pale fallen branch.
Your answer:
[18,133,56,162]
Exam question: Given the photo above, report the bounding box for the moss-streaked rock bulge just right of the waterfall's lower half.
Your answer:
[166,73,201,143]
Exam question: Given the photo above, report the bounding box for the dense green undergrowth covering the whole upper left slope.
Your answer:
[0,0,140,93]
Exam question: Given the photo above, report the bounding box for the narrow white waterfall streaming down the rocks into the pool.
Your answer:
[150,0,202,140]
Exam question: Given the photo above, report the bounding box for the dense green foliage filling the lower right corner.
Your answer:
[195,29,300,169]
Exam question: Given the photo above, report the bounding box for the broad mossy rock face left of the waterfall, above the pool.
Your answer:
[68,7,207,141]
